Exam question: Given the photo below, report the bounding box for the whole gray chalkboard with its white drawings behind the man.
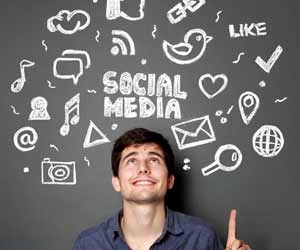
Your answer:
[0,0,300,250]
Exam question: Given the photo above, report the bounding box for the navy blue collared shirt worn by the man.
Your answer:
[73,209,224,250]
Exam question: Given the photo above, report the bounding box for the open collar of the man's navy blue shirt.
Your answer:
[109,208,183,240]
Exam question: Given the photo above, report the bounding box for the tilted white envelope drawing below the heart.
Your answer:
[171,115,216,150]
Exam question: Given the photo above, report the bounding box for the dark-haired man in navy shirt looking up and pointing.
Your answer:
[74,128,250,250]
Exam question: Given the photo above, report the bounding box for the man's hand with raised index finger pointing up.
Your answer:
[225,209,251,250]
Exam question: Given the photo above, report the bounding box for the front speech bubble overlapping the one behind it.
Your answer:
[53,57,83,85]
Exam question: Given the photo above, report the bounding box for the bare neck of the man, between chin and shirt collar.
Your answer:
[121,202,166,243]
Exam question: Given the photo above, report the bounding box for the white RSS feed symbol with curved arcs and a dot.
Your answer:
[110,30,135,56]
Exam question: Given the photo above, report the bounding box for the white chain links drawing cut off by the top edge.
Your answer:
[167,0,206,24]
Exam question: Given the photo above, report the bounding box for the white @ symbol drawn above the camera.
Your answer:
[14,127,38,152]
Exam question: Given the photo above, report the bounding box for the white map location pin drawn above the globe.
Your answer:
[239,91,260,125]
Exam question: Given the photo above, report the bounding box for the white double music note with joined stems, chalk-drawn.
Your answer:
[60,93,80,136]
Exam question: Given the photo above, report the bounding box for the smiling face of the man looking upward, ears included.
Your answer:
[112,143,174,204]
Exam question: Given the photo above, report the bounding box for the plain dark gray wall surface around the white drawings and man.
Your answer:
[0,0,300,250]
